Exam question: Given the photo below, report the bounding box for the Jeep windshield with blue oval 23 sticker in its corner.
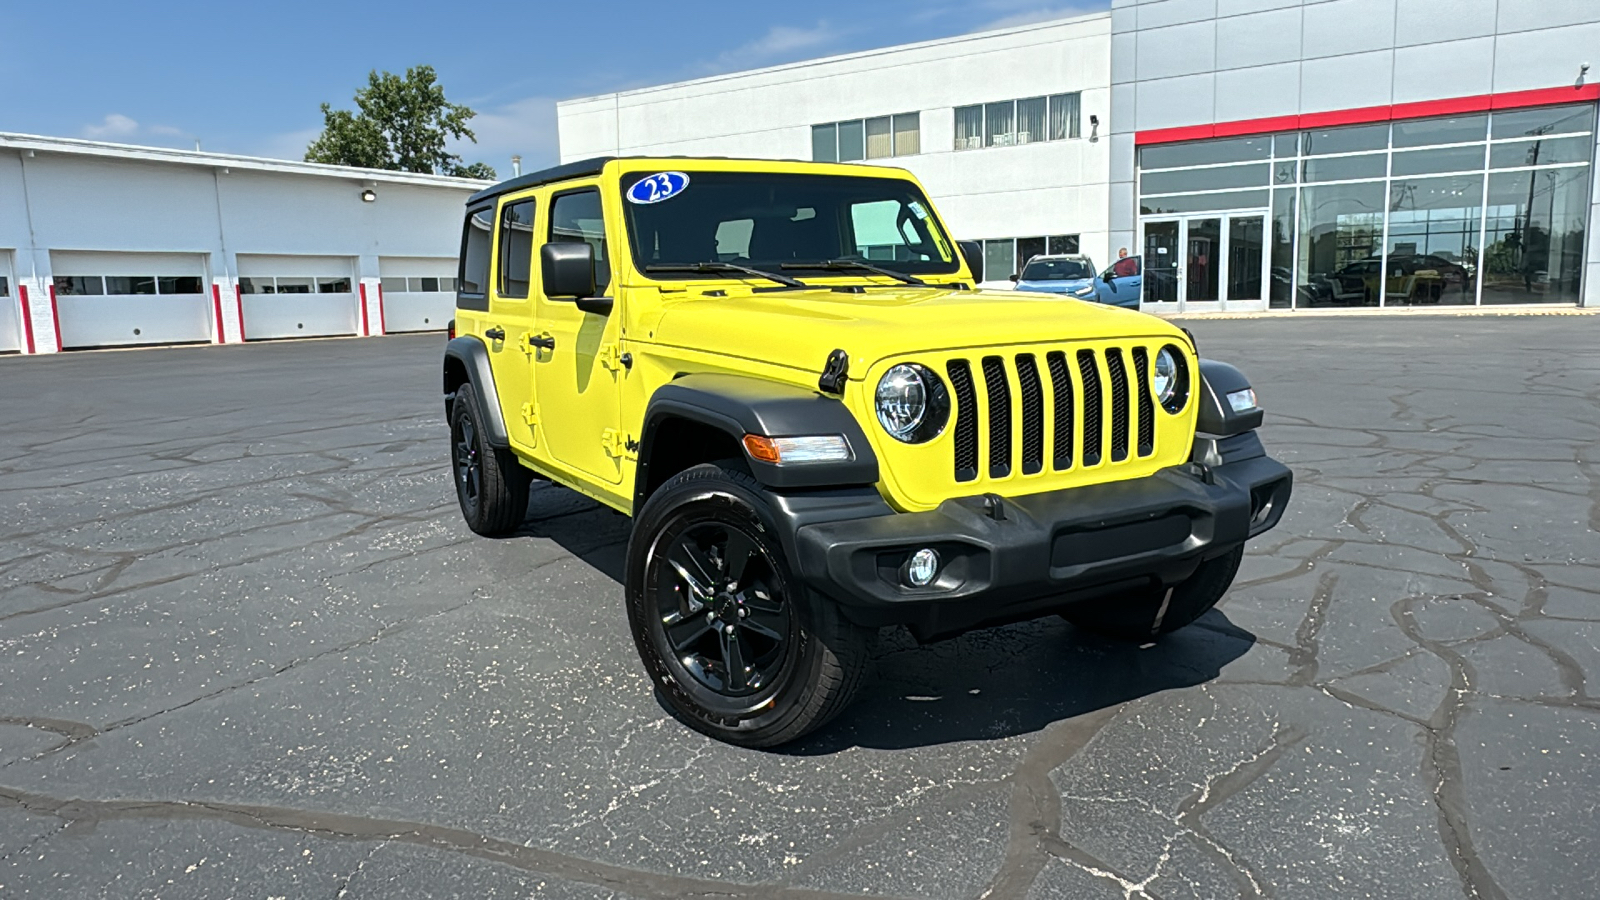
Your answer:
[622,171,960,279]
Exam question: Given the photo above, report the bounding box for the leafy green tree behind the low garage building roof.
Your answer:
[306,66,494,179]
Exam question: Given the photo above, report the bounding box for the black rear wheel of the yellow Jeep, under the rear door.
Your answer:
[450,377,533,538]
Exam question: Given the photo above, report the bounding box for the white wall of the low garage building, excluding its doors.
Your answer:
[0,136,480,349]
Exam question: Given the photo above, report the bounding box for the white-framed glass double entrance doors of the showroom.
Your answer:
[1142,213,1267,311]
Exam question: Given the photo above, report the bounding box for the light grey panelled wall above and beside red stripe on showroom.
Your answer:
[1110,0,1600,306]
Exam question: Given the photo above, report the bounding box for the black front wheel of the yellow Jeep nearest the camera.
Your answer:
[627,463,867,746]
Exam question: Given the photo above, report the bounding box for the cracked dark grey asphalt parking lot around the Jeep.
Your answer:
[0,317,1600,898]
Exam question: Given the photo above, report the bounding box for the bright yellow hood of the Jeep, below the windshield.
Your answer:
[634,287,1181,380]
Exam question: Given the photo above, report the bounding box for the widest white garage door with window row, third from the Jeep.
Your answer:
[50,250,213,348]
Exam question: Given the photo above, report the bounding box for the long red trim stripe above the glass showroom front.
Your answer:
[1133,83,1600,147]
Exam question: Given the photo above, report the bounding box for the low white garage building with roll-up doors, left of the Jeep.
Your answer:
[0,135,483,352]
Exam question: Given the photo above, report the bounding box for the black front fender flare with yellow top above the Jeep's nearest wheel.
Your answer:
[634,373,878,509]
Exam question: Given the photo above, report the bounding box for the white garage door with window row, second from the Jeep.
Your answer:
[238,253,360,341]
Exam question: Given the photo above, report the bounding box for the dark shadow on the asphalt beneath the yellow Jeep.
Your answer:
[517,484,1256,756]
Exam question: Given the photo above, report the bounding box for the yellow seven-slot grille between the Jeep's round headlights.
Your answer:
[946,348,1155,482]
